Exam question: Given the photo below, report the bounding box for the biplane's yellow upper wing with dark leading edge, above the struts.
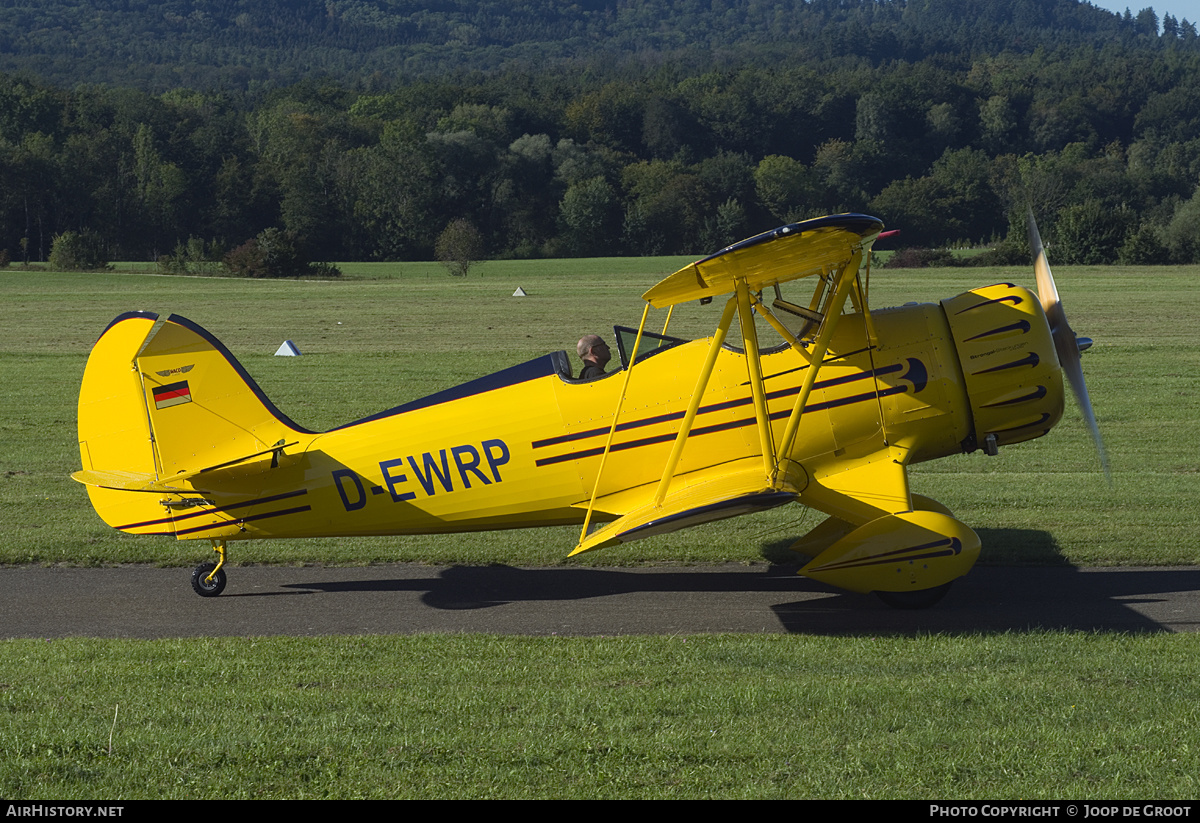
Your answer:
[642,215,883,308]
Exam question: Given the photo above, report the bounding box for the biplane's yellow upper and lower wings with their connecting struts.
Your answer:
[571,215,883,557]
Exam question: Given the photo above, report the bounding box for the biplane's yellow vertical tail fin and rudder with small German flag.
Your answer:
[72,312,311,534]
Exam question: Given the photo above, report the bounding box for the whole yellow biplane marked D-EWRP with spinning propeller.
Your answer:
[72,215,1103,608]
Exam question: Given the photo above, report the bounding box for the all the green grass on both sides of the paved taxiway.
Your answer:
[0,259,1200,799]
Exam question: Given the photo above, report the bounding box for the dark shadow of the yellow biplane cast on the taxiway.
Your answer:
[280,565,1200,635]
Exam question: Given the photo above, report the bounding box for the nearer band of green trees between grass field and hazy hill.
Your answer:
[0,0,1200,266]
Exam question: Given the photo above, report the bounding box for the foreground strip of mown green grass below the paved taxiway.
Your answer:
[0,633,1200,800]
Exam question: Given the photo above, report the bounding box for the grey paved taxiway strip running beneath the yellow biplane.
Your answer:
[0,564,1200,638]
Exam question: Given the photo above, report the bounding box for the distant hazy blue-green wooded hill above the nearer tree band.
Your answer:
[0,0,1171,91]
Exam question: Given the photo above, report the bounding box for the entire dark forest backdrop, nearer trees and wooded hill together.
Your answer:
[0,0,1200,270]
